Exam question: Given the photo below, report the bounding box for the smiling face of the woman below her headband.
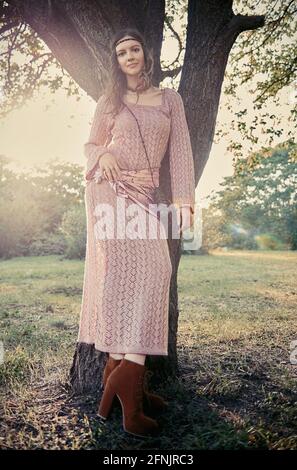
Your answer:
[116,36,144,75]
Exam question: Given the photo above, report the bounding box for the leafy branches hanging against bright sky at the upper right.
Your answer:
[221,0,297,158]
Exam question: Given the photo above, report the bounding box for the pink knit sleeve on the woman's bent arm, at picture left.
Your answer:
[84,95,113,180]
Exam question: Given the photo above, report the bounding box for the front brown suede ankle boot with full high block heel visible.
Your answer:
[97,358,159,437]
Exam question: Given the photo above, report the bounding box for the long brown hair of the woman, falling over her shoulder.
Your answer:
[104,28,154,115]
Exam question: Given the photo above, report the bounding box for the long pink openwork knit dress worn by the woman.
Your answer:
[78,88,195,355]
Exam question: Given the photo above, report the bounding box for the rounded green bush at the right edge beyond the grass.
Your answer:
[203,141,297,250]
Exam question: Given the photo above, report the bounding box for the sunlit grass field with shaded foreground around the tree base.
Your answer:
[0,251,297,450]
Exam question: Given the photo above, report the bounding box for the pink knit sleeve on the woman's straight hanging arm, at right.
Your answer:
[169,89,195,207]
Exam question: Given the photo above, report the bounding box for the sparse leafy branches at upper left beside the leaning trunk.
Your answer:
[0,16,80,118]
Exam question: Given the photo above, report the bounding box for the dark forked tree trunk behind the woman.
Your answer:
[8,0,265,392]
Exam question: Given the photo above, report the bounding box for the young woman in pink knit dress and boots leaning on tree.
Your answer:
[78,29,195,436]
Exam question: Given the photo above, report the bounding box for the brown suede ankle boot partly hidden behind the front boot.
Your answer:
[101,356,168,414]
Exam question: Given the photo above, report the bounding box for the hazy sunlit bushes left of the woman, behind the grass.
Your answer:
[0,156,85,258]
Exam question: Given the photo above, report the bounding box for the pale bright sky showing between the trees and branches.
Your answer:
[0,7,292,206]
